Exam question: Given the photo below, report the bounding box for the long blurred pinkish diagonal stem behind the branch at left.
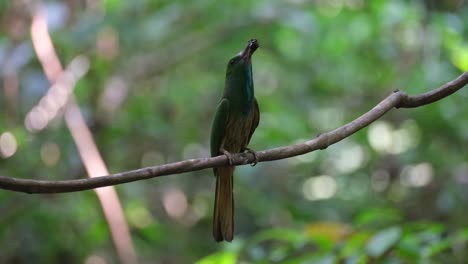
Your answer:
[31,7,137,264]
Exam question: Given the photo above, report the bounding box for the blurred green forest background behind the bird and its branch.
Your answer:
[0,0,468,264]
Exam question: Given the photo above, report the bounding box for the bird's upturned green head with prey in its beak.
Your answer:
[226,39,259,77]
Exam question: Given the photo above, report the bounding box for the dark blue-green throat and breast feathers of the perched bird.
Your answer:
[225,63,254,115]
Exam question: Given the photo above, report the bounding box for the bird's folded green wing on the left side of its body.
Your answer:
[210,98,229,157]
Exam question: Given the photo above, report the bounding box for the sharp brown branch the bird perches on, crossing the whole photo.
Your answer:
[0,72,468,193]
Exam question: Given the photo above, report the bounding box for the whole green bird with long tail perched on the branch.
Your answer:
[211,39,260,242]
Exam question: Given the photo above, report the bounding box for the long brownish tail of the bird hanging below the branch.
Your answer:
[213,167,235,242]
